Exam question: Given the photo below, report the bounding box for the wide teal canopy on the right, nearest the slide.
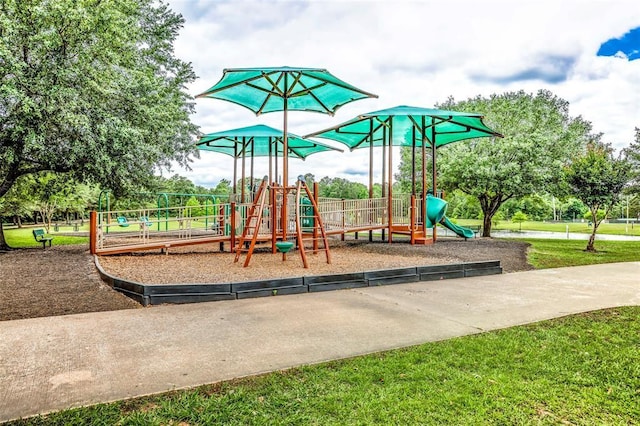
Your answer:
[305,105,502,150]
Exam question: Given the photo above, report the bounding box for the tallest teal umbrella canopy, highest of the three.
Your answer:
[197,67,378,115]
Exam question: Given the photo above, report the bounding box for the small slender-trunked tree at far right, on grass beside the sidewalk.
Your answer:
[566,143,631,251]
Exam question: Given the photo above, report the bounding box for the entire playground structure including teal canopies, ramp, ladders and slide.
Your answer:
[91,74,502,268]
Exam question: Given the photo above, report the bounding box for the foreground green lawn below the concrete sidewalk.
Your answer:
[13,307,640,425]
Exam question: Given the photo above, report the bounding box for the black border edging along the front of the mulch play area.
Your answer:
[94,255,502,306]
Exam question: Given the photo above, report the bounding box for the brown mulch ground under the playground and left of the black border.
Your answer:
[0,238,532,321]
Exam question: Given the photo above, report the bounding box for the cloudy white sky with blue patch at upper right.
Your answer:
[169,0,640,186]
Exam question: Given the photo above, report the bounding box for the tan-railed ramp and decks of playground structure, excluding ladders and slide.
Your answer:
[91,197,433,255]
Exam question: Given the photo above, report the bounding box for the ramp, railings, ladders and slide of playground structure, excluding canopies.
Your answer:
[90,177,474,267]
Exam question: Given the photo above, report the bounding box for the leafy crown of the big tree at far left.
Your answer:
[0,0,197,247]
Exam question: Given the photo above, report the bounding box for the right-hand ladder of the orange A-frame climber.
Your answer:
[296,178,331,268]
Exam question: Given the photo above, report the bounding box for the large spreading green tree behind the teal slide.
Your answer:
[401,90,592,237]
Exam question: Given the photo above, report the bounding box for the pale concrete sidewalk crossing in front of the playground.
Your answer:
[0,262,640,422]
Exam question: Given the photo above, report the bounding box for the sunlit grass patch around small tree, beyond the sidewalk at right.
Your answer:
[521,239,640,269]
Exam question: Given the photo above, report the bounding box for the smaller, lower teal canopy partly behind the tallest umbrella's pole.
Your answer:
[196,124,342,160]
